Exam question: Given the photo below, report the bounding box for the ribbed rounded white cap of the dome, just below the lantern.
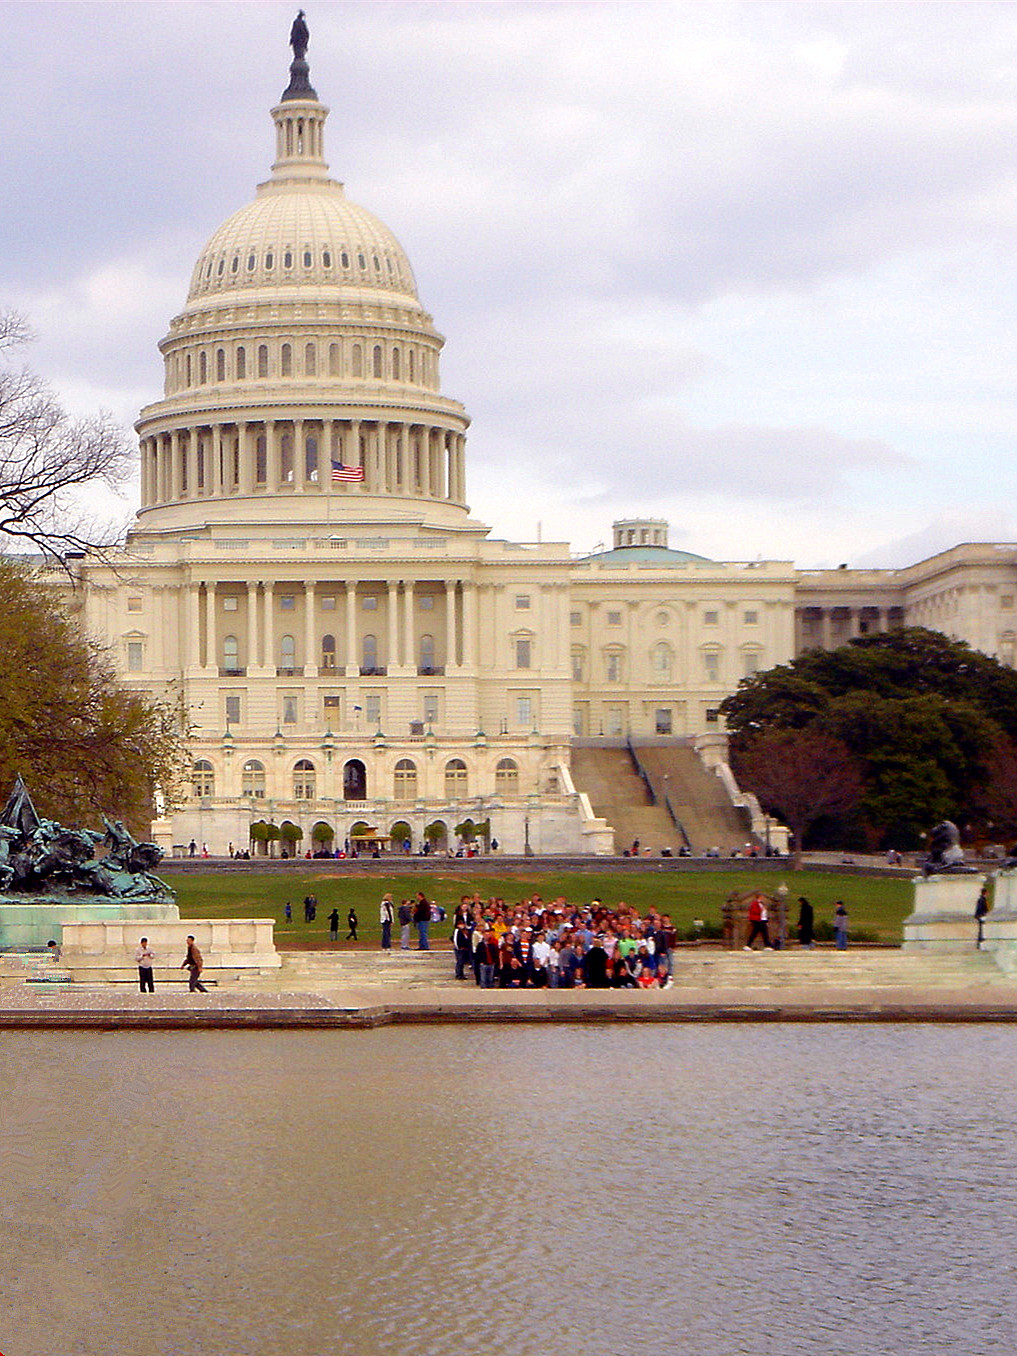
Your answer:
[187,179,416,302]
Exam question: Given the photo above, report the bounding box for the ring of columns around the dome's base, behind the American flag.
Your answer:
[141,419,466,507]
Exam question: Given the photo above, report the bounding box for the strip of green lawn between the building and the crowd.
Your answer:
[168,864,911,948]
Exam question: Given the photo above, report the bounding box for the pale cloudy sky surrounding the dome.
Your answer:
[0,0,1017,565]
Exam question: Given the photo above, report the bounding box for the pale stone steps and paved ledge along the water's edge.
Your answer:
[0,946,1017,1031]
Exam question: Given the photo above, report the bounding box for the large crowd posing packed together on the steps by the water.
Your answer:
[453,895,675,989]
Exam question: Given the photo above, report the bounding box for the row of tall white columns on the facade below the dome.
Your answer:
[186,579,477,678]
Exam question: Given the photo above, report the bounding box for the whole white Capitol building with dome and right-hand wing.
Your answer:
[67,20,1017,853]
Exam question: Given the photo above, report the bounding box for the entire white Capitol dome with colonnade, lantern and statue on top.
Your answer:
[136,29,469,532]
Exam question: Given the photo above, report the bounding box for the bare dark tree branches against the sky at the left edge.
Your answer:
[0,312,133,564]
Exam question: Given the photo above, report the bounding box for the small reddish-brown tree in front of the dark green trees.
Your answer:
[735,730,861,868]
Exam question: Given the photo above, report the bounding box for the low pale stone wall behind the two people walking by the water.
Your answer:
[61,918,282,986]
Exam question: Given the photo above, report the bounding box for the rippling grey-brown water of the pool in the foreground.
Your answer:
[0,1025,1017,1356]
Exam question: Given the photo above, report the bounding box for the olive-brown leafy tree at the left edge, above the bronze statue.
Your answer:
[0,556,188,833]
